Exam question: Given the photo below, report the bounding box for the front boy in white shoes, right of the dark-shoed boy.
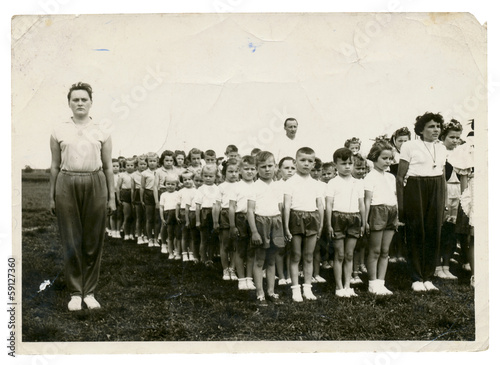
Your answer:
[283,147,324,302]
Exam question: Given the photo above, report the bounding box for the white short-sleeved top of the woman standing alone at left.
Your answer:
[52,118,111,172]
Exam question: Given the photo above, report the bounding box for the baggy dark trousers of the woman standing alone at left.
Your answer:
[55,170,108,296]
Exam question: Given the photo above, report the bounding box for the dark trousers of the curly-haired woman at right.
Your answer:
[403,176,445,281]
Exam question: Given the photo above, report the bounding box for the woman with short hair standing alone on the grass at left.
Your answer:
[49,83,116,311]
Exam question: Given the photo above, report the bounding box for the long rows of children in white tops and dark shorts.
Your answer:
[105,118,472,302]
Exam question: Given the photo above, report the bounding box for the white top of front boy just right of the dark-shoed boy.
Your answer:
[283,174,323,212]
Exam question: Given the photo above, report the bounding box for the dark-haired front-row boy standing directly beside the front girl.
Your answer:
[326,148,365,297]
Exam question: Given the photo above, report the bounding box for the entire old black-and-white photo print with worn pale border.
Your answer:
[11,2,489,354]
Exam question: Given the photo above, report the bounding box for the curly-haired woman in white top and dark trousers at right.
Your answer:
[396,113,446,292]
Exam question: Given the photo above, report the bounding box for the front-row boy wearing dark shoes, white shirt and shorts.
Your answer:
[247,151,285,305]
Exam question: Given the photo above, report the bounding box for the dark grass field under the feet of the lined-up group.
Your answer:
[22,173,475,342]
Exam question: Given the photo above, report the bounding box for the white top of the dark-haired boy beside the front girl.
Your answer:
[326,176,365,213]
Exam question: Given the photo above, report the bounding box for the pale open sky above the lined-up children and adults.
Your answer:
[12,13,486,168]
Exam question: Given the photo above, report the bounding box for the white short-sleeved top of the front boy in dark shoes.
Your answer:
[248,179,283,217]
